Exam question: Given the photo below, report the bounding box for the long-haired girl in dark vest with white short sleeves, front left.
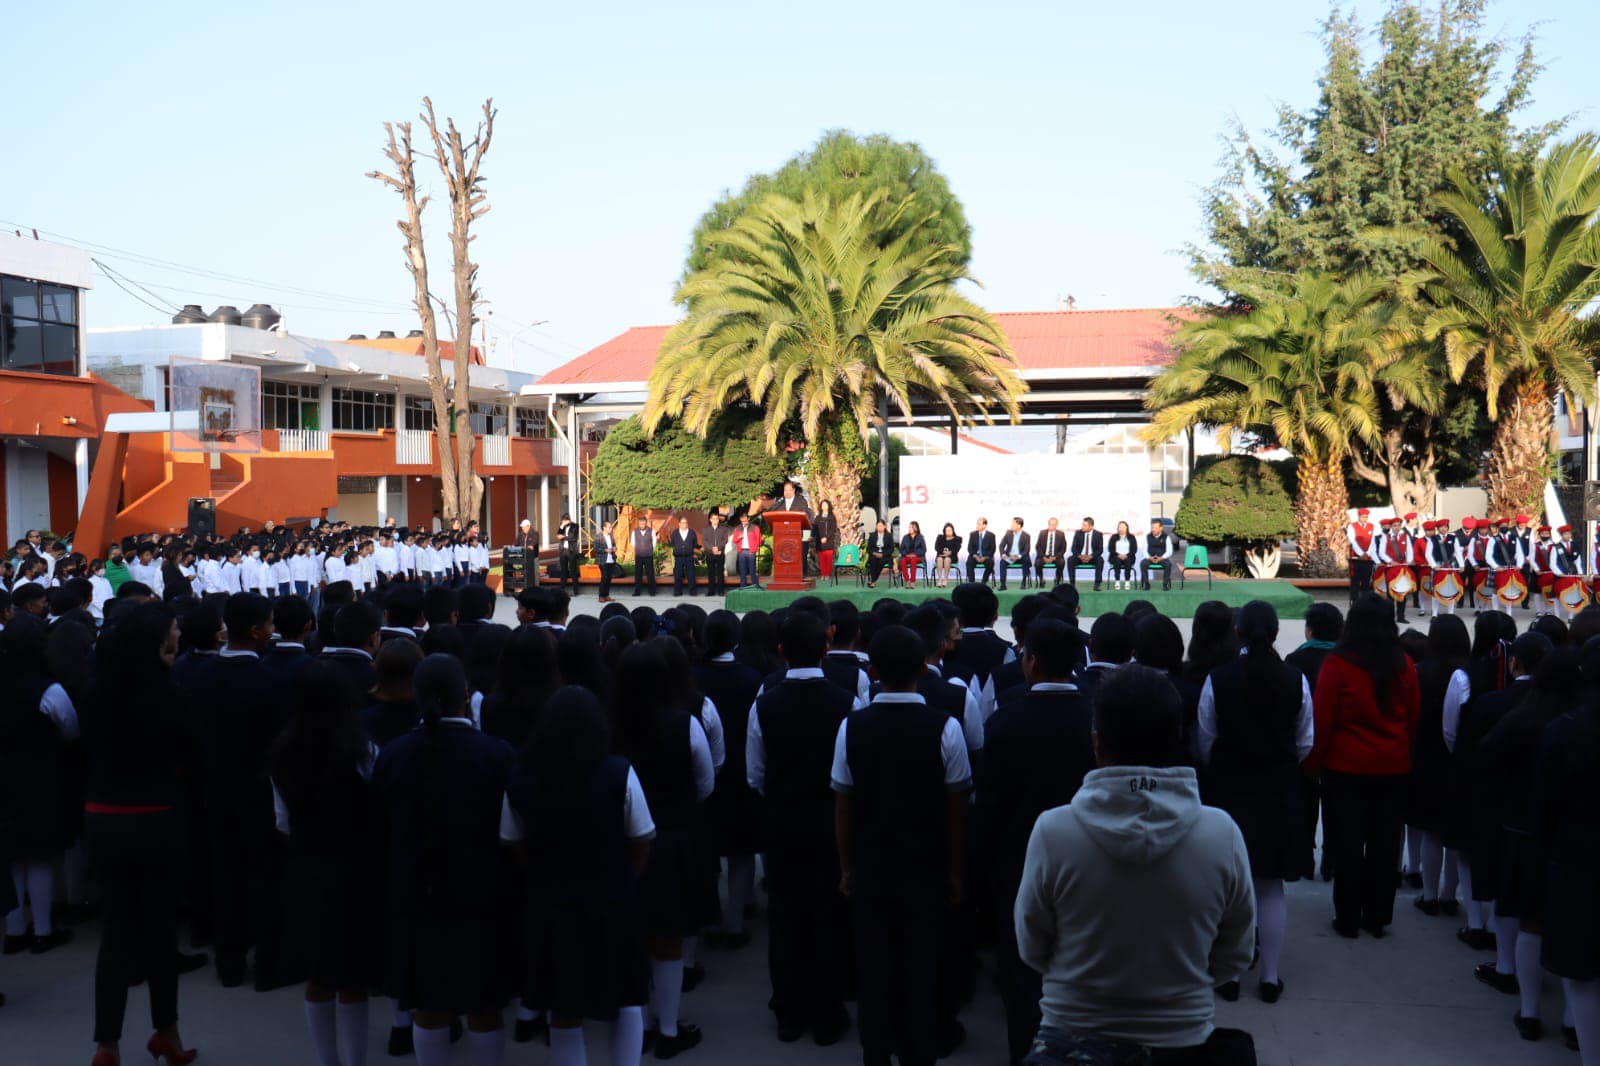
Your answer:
[501,685,656,1066]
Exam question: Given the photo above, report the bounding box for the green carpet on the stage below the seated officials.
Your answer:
[728,578,1314,618]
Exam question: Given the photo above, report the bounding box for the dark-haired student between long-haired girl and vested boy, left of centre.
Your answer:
[696,611,762,949]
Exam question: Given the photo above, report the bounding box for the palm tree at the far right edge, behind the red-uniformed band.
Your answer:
[1413,134,1600,515]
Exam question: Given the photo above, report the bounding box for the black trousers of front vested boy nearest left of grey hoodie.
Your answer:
[851,879,946,1066]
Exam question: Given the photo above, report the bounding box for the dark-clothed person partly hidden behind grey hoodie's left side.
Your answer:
[974,619,1094,1063]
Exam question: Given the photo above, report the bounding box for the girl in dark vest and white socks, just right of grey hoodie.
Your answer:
[1195,600,1315,1004]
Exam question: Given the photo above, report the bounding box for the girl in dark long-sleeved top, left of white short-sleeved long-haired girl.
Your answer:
[371,655,515,1066]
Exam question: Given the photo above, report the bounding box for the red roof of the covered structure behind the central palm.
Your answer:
[539,307,1187,386]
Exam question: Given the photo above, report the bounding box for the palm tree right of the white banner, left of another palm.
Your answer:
[1146,272,1426,573]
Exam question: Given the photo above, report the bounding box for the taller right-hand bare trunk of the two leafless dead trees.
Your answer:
[422,96,496,522]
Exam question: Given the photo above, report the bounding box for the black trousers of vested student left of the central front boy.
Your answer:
[766,837,846,1024]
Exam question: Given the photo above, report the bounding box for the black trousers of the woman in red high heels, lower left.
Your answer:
[83,812,184,1044]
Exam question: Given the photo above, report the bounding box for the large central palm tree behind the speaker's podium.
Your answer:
[643,192,1026,543]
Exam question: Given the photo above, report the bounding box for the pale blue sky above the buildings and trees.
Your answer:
[0,0,1600,370]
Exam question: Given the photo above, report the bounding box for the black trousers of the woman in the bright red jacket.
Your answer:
[1322,770,1411,928]
